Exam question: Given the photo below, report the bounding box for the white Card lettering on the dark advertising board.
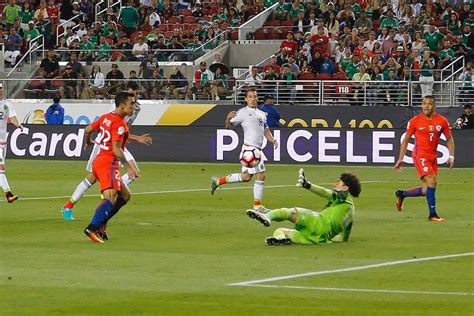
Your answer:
[8,127,84,158]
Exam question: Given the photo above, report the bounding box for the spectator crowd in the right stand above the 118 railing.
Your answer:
[252,0,474,102]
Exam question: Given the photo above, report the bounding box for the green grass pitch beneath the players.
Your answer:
[0,160,474,315]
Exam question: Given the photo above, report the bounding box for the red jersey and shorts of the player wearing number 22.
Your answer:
[91,112,129,191]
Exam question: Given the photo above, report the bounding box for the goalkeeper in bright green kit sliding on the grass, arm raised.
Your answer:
[247,169,361,245]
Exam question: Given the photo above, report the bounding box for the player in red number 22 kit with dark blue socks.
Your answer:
[84,92,138,243]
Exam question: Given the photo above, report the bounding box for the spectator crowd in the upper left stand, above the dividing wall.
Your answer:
[0,0,263,65]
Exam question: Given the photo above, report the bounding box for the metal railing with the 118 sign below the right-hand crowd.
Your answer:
[234,80,474,107]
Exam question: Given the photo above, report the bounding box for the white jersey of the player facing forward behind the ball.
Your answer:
[230,106,268,148]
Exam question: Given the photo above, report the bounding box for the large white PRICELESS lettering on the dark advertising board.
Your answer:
[216,129,449,164]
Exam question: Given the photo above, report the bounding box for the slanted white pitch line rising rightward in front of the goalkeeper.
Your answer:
[227,252,474,286]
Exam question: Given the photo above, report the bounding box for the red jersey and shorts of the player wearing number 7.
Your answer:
[405,113,451,177]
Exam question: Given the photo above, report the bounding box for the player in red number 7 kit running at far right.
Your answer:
[393,96,454,222]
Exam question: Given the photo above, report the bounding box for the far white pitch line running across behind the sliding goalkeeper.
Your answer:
[0,180,386,203]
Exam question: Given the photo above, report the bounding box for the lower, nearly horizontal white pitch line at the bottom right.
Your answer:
[235,284,474,296]
